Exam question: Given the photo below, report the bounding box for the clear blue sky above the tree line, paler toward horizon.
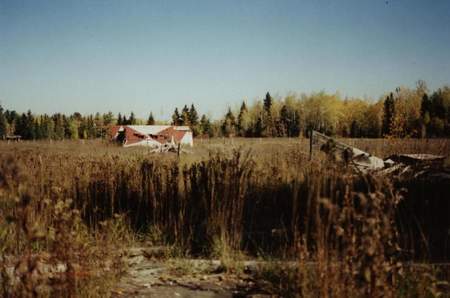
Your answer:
[0,0,450,119]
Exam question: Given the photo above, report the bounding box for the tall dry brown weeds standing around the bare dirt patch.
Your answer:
[0,139,449,297]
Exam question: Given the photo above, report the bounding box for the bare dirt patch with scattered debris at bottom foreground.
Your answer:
[112,248,276,298]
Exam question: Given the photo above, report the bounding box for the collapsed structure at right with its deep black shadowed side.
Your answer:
[310,131,450,262]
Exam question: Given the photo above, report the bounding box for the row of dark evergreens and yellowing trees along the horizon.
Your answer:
[0,81,450,140]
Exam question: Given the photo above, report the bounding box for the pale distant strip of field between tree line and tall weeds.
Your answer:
[0,138,450,161]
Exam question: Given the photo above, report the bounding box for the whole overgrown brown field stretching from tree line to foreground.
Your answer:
[0,138,450,297]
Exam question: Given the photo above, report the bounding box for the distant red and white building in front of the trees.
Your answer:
[111,125,194,147]
